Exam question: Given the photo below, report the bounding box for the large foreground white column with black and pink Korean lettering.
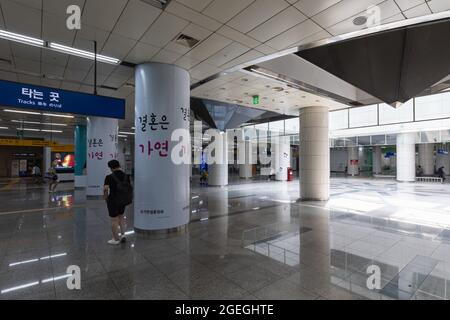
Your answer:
[134,63,191,232]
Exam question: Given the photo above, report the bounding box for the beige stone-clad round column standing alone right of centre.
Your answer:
[300,107,330,200]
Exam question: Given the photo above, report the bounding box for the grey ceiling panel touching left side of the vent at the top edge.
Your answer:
[114,0,162,40]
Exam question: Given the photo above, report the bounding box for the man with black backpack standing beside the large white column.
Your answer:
[103,160,133,245]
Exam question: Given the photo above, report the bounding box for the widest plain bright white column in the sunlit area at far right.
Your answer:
[397,133,416,182]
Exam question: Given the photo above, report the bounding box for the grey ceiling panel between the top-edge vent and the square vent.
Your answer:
[141,12,189,48]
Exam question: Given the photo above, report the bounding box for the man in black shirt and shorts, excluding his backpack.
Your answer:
[103,160,130,245]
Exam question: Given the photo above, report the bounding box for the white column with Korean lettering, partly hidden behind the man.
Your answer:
[86,117,119,196]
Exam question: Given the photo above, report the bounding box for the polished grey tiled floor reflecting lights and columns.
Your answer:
[0,178,450,299]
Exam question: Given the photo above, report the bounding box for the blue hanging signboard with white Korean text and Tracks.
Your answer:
[0,80,125,119]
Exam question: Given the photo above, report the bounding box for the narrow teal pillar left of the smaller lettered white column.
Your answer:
[74,125,87,188]
